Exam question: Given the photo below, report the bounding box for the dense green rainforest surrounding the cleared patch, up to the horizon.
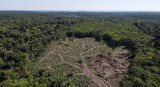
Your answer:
[0,11,160,87]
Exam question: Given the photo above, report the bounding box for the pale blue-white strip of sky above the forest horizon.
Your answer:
[0,0,160,11]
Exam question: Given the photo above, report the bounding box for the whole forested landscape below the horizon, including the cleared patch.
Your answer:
[0,11,160,87]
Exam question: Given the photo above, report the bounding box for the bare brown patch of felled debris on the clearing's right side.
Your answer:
[91,49,130,87]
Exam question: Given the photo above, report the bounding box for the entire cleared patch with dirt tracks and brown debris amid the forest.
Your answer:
[37,38,130,87]
